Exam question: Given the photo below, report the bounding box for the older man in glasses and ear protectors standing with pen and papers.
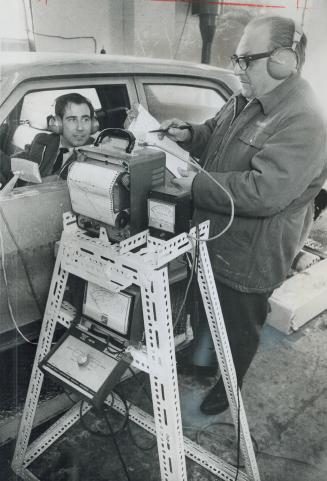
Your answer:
[160,16,327,414]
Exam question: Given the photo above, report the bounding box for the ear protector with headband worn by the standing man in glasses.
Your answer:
[267,22,303,80]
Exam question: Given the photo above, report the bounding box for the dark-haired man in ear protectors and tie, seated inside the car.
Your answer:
[6,93,99,181]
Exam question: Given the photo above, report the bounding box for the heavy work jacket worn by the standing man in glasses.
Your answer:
[186,75,327,292]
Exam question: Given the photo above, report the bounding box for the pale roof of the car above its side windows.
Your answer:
[0,52,238,103]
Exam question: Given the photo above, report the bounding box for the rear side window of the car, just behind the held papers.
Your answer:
[144,84,225,123]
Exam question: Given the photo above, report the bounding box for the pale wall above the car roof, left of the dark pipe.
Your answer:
[31,0,201,61]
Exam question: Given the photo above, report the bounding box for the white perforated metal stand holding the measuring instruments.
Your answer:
[12,213,260,481]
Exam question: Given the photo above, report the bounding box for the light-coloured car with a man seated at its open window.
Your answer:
[0,52,239,350]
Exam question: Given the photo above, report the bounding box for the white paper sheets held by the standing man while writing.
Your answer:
[128,105,189,178]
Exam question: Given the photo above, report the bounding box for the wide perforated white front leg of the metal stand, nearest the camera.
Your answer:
[141,267,187,481]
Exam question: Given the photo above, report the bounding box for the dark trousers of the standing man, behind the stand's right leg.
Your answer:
[190,280,272,386]
